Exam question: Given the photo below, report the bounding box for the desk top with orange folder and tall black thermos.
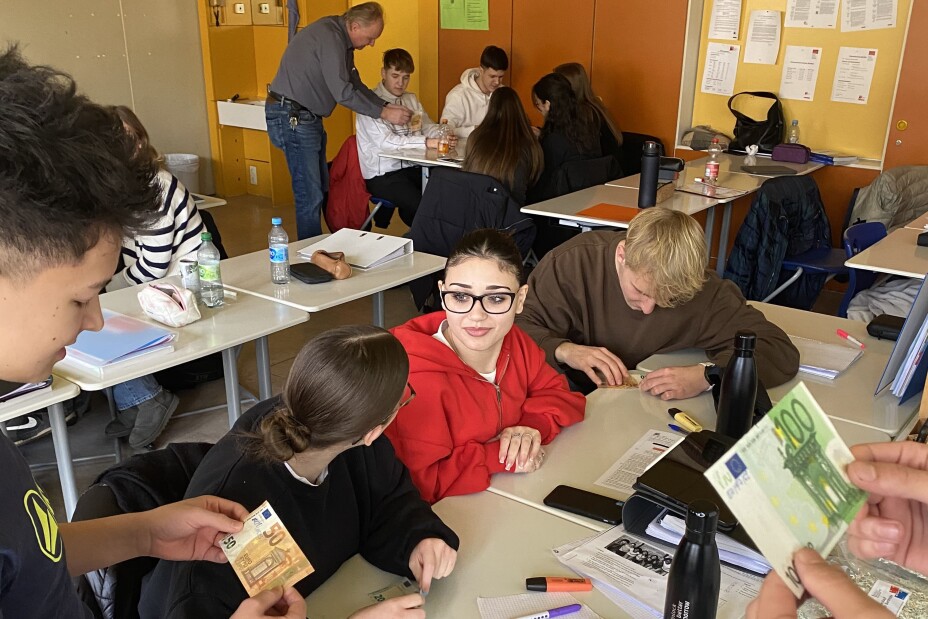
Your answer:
[522,185,719,228]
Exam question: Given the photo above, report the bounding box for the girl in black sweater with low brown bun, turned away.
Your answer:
[139,326,458,619]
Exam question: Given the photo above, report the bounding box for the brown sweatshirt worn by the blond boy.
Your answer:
[516,232,799,387]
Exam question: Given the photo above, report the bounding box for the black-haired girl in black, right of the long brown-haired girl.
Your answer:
[528,73,602,204]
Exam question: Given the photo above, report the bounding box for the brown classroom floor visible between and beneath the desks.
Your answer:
[22,196,841,517]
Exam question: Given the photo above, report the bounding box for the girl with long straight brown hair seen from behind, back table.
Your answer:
[461,86,543,205]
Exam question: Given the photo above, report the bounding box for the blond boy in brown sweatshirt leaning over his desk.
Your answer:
[516,207,799,400]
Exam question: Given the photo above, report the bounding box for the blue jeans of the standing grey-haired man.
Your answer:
[264,101,329,240]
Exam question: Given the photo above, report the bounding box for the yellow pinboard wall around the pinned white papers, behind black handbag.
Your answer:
[693,0,911,159]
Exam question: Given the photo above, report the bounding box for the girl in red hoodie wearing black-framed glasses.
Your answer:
[386,229,586,503]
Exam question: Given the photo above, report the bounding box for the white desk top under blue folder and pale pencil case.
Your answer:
[55,278,309,391]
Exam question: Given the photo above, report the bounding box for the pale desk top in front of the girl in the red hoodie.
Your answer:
[489,380,890,531]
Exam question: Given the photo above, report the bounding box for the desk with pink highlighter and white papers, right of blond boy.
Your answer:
[638,302,919,440]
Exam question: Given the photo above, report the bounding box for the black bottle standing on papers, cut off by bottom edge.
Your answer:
[664,499,722,619]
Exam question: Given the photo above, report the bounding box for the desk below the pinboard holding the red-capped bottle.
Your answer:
[606,153,823,275]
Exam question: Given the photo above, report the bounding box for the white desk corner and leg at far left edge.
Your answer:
[0,376,80,520]
